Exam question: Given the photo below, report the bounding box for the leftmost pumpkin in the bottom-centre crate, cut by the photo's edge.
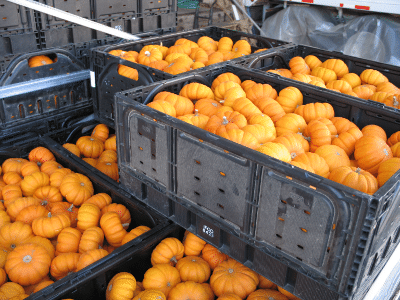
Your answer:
[106,272,136,300]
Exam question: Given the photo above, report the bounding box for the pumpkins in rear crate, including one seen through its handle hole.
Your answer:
[109,36,267,80]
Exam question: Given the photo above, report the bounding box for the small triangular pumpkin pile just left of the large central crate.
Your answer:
[63,124,119,182]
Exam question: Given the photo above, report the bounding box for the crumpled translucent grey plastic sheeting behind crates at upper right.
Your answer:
[262,6,400,66]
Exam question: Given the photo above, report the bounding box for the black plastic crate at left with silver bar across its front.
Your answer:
[0,49,93,138]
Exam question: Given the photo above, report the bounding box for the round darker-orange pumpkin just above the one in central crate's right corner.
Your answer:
[354,136,393,175]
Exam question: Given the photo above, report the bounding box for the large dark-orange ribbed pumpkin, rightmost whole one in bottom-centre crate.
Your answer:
[210,259,259,299]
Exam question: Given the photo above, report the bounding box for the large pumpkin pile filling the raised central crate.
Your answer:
[147,73,400,194]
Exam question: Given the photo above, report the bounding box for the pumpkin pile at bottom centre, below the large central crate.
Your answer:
[106,232,299,300]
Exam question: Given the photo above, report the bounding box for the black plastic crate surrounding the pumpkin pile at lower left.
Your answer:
[0,131,171,299]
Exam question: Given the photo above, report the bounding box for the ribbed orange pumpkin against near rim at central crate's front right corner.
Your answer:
[329,166,378,195]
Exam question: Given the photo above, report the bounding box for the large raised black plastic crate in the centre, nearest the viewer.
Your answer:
[115,65,400,300]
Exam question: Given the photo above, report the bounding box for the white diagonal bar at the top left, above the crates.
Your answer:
[7,0,140,40]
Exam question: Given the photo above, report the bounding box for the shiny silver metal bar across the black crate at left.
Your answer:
[0,70,90,98]
